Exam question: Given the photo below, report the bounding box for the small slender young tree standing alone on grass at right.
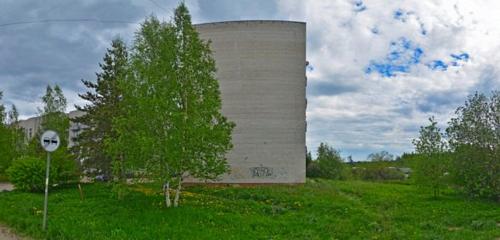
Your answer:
[412,117,449,198]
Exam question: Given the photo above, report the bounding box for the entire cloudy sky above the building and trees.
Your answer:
[0,0,500,160]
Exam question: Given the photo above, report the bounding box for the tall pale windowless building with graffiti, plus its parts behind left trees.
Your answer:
[17,21,307,183]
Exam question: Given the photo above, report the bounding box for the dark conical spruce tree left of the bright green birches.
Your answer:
[72,38,128,175]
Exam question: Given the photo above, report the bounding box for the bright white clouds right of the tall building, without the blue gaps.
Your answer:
[278,0,500,160]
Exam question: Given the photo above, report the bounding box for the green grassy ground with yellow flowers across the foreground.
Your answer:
[0,180,500,239]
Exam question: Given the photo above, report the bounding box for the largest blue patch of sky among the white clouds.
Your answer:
[365,37,424,77]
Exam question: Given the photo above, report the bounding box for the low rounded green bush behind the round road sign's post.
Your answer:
[7,157,58,192]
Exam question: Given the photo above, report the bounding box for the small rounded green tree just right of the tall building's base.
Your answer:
[316,143,344,179]
